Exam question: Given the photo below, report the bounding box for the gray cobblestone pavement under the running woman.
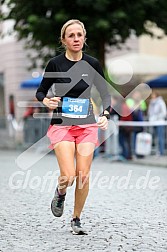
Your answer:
[0,151,167,252]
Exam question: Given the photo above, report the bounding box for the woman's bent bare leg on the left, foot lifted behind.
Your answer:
[54,141,75,194]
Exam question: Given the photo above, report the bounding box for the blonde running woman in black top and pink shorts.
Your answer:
[36,19,111,234]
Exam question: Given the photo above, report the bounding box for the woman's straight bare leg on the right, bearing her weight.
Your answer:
[73,143,95,218]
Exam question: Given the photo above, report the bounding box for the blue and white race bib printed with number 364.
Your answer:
[62,97,89,118]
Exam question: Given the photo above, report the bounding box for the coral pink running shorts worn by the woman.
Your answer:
[47,123,98,150]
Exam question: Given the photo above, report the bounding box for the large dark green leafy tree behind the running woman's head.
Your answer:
[1,0,167,65]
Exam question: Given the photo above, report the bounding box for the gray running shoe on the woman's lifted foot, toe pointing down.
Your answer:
[51,188,66,217]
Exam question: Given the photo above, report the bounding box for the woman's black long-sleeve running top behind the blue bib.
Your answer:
[36,53,111,125]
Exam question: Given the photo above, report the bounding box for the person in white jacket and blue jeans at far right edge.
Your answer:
[148,91,167,155]
